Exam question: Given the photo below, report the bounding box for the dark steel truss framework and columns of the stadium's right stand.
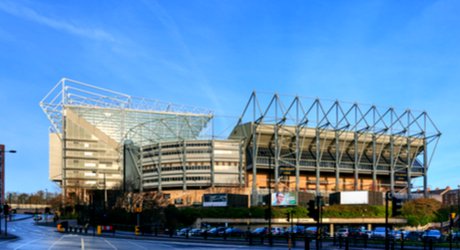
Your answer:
[237,92,441,199]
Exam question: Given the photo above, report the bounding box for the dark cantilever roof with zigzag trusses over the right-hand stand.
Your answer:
[230,92,441,197]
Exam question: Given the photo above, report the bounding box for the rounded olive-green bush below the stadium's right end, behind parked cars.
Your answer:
[402,198,441,227]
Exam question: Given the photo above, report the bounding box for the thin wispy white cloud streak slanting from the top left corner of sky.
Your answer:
[0,2,115,42]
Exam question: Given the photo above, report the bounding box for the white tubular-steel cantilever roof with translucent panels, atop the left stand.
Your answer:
[40,78,213,145]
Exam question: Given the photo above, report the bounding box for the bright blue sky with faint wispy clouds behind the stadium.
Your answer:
[0,0,460,193]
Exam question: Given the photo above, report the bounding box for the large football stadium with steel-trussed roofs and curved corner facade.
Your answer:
[40,78,441,205]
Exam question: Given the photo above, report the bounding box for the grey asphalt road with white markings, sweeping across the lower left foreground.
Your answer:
[0,218,294,250]
